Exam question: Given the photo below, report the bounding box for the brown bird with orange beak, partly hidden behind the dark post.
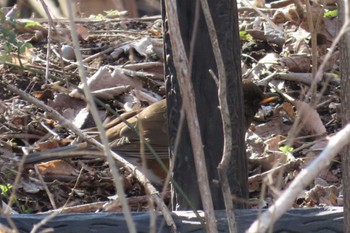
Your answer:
[25,80,277,183]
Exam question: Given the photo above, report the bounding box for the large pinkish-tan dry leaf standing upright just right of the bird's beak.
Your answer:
[294,100,326,134]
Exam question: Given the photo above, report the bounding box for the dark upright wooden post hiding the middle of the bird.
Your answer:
[163,0,248,209]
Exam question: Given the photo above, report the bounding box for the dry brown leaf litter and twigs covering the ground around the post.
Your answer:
[0,0,342,212]
